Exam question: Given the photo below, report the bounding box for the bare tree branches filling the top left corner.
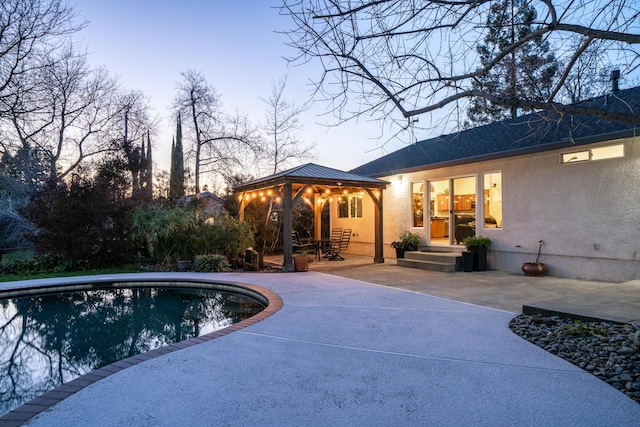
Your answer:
[0,0,85,116]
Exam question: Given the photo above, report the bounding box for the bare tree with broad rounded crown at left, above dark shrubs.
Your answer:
[7,45,122,181]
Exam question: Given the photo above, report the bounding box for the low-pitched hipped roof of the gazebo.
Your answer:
[234,163,389,192]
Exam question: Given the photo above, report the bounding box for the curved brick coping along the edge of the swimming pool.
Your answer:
[0,276,283,427]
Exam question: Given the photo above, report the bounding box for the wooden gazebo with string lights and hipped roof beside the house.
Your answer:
[234,163,389,271]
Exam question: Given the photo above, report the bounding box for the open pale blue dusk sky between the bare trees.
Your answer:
[75,0,418,179]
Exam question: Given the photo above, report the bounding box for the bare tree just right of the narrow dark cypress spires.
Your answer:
[174,70,258,195]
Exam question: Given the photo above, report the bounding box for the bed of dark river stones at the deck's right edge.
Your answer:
[509,315,640,403]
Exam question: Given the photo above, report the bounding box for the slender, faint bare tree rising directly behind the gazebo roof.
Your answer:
[263,77,315,173]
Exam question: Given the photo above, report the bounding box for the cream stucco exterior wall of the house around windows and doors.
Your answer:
[338,139,640,282]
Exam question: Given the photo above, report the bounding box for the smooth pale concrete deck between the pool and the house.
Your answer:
[0,263,640,426]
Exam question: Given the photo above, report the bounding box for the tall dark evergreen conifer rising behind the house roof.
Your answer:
[465,0,558,127]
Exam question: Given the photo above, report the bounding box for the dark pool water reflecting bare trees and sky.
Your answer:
[0,288,264,416]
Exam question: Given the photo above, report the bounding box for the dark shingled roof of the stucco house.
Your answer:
[351,87,640,177]
